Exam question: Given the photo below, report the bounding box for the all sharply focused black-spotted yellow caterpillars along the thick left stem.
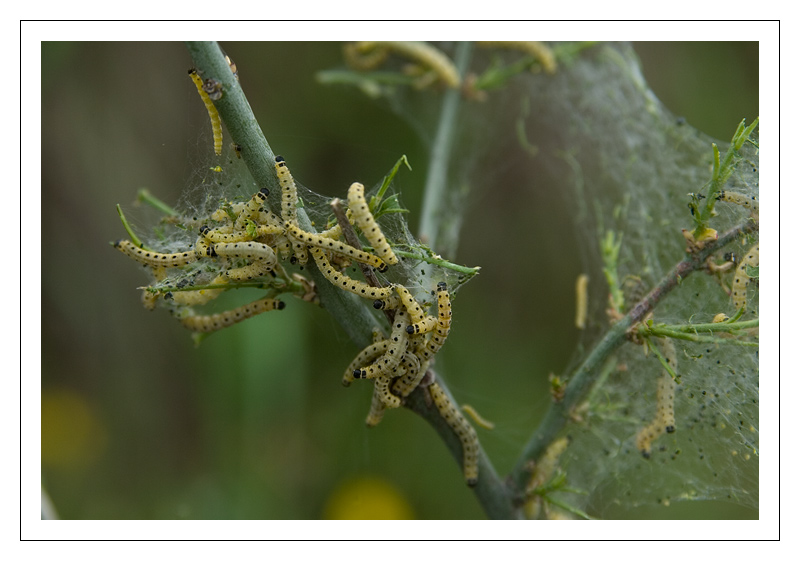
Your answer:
[113,99,478,476]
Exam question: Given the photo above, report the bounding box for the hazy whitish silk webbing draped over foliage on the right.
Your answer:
[325,44,758,516]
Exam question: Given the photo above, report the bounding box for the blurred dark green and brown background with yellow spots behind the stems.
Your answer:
[41,42,758,519]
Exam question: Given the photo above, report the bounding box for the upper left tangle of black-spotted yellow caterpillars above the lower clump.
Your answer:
[113,155,400,333]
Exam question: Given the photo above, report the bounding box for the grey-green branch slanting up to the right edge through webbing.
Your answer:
[508,220,758,493]
